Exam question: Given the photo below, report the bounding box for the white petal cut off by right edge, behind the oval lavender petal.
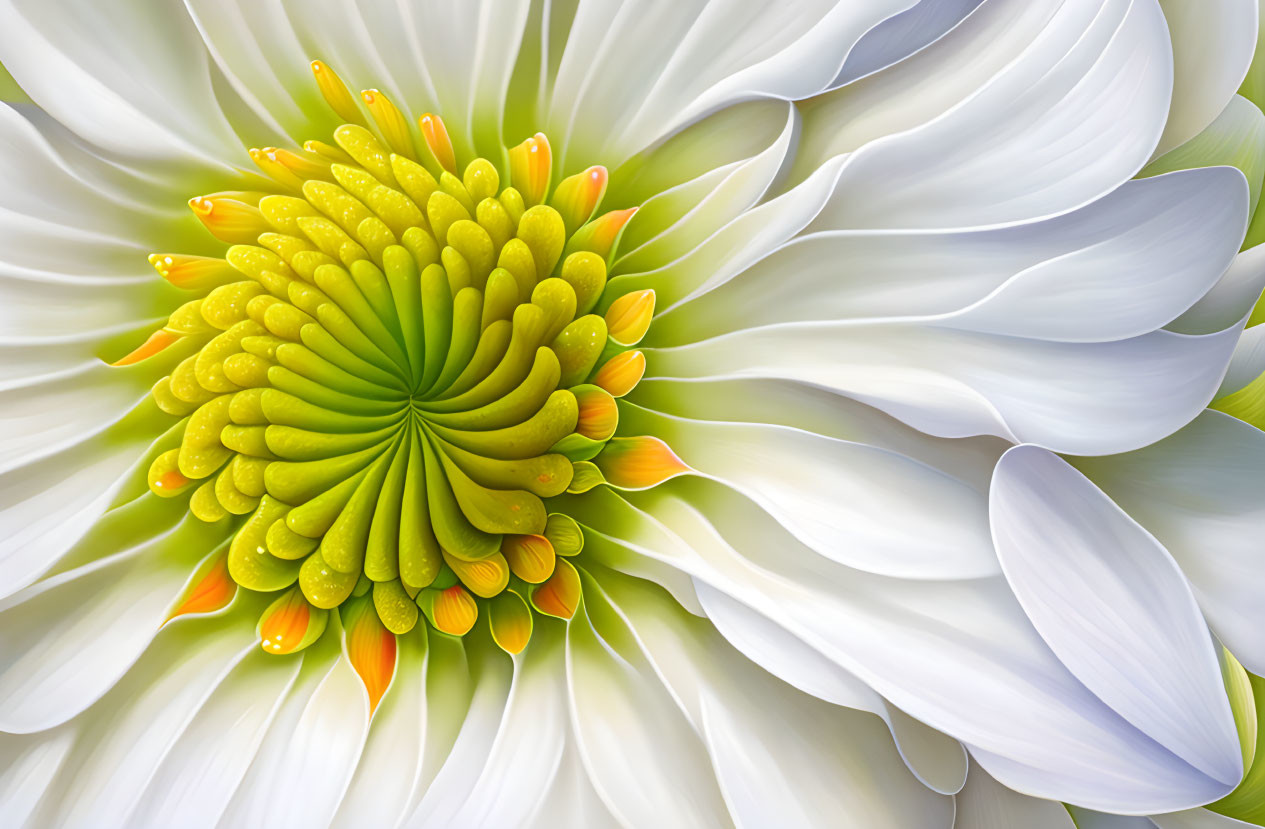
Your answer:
[1075,411,1265,673]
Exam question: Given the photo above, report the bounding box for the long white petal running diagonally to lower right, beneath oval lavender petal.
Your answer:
[573,491,1254,814]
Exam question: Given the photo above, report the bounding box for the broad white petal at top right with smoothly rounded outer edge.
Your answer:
[813,0,1171,229]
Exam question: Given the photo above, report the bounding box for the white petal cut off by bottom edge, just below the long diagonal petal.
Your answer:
[586,572,951,829]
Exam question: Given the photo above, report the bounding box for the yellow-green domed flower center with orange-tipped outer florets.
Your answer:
[116,62,683,673]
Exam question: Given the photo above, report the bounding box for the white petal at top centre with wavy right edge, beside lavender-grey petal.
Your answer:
[546,0,913,170]
